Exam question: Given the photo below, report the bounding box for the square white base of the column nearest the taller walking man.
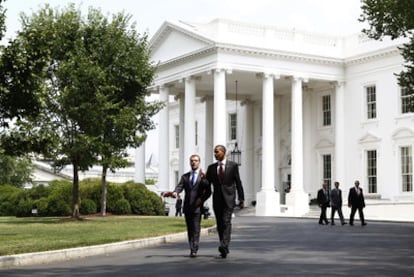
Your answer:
[256,191,280,216]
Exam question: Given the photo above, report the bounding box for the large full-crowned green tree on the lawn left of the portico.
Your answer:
[2,4,159,218]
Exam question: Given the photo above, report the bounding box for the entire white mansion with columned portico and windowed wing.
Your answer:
[137,19,414,216]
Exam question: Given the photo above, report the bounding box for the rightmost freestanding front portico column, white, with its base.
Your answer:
[286,77,309,216]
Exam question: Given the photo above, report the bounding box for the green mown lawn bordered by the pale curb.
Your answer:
[0,216,215,256]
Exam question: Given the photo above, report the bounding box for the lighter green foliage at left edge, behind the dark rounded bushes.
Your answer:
[0,149,34,187]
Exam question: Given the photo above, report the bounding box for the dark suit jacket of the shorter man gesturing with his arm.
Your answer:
[174,171,211,214]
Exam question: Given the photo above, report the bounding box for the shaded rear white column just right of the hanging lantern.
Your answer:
[241,100,256,205]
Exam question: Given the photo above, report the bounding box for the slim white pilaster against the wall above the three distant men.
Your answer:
[335,82,345,184]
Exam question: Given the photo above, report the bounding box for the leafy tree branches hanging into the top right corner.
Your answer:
[360,0,414,112]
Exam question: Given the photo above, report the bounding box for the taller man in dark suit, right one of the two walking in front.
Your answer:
[207,145,244,258]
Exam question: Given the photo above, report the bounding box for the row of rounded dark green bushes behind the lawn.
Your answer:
[0,179,164,217]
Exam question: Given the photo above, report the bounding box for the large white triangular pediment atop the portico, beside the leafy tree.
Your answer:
[150,22,214,63]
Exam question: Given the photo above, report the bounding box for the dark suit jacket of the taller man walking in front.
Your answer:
[206,160,244,208]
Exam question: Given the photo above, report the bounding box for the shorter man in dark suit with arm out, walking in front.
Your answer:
[172,155,211,258]
